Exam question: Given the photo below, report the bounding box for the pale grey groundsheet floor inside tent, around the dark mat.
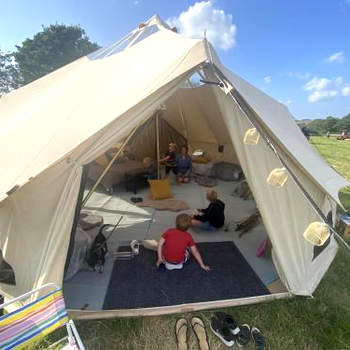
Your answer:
[63,176,286,310]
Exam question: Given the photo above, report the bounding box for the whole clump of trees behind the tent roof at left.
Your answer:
[0,24,100,96]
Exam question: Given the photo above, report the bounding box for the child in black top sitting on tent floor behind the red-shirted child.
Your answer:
[192,190,225,231]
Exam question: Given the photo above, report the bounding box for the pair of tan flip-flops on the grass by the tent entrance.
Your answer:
[175,317,210,350]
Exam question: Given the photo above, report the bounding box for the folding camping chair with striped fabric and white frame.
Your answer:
[0,283,85,350]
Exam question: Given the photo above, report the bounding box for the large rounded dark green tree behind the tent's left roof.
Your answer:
[13,24,100,84]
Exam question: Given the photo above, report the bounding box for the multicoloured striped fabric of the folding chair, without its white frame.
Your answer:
[0,290,68,350]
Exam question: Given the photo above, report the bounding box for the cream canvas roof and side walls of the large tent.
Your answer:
[0,17,348,308]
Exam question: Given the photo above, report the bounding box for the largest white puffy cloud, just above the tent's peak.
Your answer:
[167,0,237,50]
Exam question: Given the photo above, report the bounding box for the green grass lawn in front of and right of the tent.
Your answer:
[38,137,350,350]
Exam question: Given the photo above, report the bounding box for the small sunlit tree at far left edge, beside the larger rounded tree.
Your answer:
[0,51,22,96]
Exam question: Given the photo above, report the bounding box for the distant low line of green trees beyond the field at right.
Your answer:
[306,114,350,135]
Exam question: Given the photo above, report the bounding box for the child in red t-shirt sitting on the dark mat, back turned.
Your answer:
[157,214,210,271]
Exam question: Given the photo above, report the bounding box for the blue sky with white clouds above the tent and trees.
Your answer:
[0,0,350,118]
